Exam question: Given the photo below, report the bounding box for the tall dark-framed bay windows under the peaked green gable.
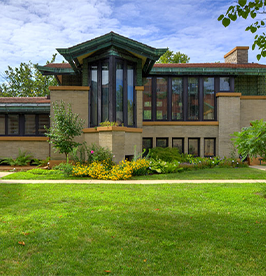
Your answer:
[89,56,136,127]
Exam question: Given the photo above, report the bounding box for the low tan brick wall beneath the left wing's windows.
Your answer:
[0,141,49,160]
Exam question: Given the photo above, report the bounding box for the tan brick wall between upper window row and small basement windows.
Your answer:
[142,125,219,156]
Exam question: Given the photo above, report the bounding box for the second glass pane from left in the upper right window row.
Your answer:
[156,78,167,120]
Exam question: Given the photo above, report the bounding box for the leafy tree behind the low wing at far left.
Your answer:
[0,54,57,97]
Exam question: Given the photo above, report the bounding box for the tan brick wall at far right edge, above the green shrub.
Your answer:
[240,97,266,128]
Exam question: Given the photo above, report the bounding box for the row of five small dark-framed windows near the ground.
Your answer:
[142,138,216,157]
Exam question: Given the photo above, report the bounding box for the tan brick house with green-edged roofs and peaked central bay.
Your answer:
[0,32,266,162]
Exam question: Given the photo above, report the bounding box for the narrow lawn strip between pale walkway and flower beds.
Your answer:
[3,168,266,180]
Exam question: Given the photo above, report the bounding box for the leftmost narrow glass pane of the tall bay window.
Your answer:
[91,66,98,126]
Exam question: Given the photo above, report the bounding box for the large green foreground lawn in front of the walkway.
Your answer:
[0,183,266,276]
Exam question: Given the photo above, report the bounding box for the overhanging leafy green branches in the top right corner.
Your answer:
[218,0,266,60]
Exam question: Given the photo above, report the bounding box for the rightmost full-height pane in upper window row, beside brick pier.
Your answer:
[203,78,214,120]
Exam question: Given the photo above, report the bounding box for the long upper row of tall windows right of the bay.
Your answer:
[143,77,233,121]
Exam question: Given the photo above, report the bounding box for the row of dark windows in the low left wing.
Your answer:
[0,114,50,136]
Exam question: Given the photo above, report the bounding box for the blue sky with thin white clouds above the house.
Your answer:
[0,0,266,80]
